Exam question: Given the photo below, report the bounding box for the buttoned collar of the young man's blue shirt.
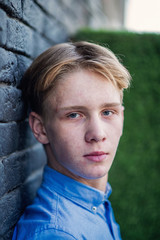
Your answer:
[43,166,112,211]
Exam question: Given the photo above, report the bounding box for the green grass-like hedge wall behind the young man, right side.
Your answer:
[73,29,160,240]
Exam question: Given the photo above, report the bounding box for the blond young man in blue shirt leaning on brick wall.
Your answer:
[13,42,130,240]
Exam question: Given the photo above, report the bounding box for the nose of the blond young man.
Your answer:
[85,118,106,143]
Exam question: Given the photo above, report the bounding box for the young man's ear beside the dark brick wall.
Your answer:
[29,112,49,144]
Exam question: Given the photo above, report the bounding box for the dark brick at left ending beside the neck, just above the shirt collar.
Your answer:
[0,144,46,197]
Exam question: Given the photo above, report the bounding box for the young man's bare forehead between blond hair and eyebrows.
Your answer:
[46,70,120,109]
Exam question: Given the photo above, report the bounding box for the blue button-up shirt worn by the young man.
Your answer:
[12,166,121,240]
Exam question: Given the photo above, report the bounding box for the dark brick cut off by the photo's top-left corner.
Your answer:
[0,0,22,19]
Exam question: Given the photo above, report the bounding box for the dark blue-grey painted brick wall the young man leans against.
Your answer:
[0,0,90,240]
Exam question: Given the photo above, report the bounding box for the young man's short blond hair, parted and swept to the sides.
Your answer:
[22,42,131,115]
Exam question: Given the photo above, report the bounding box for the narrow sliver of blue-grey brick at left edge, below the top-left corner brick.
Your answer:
[0,9,7,46]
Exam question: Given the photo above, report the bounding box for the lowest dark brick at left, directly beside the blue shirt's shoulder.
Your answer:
[0,168,43,239]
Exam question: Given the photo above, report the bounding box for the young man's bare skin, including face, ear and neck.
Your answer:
[29,70,123,191]
